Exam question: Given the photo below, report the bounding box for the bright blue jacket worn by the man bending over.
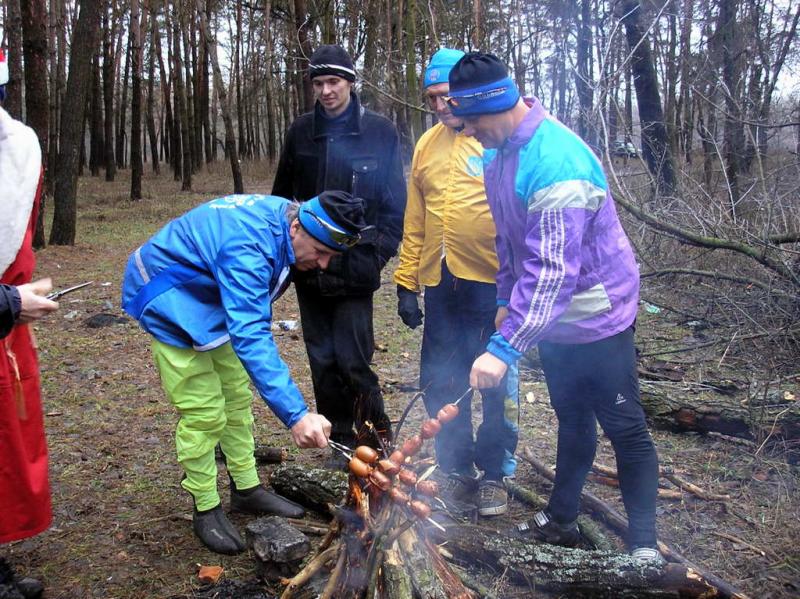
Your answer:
[122,195,308,427]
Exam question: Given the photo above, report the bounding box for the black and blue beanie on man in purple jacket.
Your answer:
[449,52,520,116]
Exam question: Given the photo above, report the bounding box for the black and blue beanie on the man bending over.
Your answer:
[297,191,366,252]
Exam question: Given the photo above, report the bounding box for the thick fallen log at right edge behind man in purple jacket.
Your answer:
[642,382,800,439]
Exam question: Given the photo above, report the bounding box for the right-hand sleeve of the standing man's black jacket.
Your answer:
[378,124,406,267]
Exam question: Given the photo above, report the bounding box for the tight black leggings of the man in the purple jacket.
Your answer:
[539,327,658,548]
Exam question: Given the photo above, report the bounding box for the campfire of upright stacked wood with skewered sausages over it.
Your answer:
[281,396,475,599]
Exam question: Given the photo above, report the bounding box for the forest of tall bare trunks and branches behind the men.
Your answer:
[0,0,800,376]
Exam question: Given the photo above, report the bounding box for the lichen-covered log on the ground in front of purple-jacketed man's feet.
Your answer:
[437,525,714,598]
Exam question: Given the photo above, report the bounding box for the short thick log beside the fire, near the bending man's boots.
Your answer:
[269,464,347,512]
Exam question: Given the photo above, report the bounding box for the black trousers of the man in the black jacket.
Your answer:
[297,287,391,444]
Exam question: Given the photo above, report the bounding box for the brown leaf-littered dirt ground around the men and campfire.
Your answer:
[2,164,800,599]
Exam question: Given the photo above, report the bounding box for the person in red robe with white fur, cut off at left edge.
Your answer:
[0,50,58,597]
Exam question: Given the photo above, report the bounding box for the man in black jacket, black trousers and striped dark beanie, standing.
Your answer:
[272,45,406,465]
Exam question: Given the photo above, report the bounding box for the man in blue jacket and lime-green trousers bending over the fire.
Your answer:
[122,191,364,554]
